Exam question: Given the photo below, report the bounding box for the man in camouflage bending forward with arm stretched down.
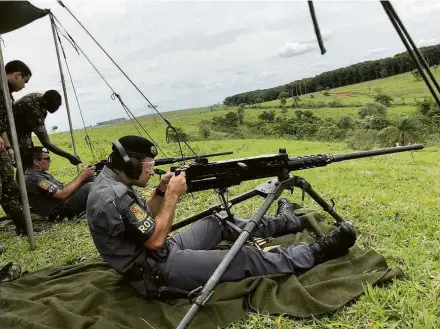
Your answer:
[14,90,81,165]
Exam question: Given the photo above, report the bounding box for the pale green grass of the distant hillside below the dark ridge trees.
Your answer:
[84,70,434,141]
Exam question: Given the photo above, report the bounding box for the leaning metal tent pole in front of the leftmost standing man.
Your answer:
[0,38,35,250]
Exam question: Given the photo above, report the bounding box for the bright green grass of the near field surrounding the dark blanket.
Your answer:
[0,136,440,329]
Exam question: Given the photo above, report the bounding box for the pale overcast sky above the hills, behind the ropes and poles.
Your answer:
[2,0,440,131]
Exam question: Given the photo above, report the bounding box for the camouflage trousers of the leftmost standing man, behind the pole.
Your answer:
[0,150,26,232]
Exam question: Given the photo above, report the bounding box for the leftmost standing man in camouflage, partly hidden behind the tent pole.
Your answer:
[0,61,32,234]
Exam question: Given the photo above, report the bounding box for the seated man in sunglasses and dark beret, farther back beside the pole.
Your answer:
[25,146,95,220]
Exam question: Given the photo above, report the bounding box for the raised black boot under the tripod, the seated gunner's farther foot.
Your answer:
[265,198,308,236]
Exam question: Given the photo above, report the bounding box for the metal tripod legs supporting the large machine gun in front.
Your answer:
[171,176,344,329]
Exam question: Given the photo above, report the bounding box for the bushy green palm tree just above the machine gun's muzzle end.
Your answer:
[379,116,422,146]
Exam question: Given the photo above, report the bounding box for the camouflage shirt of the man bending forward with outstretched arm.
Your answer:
[9,93,47,162]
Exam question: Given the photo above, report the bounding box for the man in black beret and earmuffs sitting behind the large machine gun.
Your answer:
[87,136,356,298]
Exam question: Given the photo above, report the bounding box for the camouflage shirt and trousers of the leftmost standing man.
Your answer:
[0,83,26,232]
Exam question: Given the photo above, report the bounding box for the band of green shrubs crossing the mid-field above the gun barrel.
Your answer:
[193,95,440,150]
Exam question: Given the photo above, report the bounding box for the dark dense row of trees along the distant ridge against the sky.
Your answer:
[223,44,440,106]
